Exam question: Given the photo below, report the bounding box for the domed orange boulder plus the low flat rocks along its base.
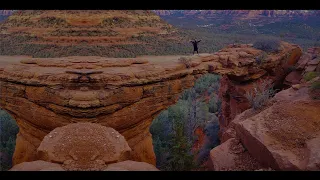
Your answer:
[11,123,158,171]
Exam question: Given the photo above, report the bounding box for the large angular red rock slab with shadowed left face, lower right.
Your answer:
[236,100,320,170]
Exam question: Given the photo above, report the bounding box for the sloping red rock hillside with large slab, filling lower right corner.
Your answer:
[210,48,320,171]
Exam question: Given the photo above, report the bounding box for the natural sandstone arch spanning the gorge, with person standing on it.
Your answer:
[0,42,301,164]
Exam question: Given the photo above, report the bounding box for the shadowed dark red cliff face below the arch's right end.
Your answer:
[219,43,302,136]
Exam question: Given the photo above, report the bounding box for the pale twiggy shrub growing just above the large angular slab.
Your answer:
[245,80,275,109]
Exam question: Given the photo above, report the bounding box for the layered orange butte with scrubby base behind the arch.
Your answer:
[0,10,182,57]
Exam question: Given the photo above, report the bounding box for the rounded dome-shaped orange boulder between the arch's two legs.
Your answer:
[38,123,131,170]
